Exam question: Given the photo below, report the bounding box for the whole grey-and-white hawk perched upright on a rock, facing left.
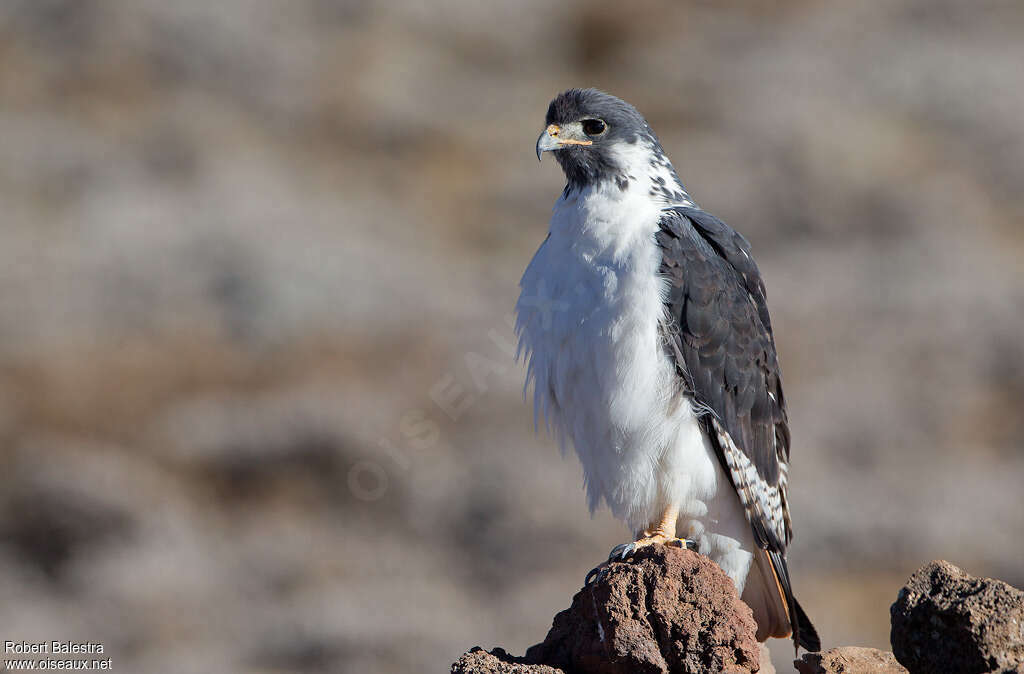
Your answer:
[516,89,820,650]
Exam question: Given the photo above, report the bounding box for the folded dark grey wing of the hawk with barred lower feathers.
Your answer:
[657,207,793,554]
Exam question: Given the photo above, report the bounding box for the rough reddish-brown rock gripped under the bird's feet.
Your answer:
[525,545,760,674]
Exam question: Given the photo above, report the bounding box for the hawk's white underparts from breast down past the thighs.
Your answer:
[516,182,754,591]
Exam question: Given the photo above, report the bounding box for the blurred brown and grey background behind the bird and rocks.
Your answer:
[0,0,1024,673]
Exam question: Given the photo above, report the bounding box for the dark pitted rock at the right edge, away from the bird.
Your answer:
[890,560,1024,674]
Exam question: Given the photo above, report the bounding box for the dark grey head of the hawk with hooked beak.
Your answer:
[537,89,664,187]
